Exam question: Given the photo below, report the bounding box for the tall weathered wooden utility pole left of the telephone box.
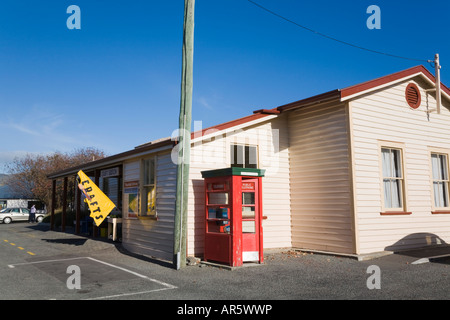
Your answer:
[173,0,195,270]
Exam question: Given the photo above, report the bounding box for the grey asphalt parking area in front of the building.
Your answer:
[0,224,450,300]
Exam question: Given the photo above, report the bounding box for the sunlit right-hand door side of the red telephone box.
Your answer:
[241,178,262,262]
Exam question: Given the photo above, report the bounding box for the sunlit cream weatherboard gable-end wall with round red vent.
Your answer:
[350,78,450,253]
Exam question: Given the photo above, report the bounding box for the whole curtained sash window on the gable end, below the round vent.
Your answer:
[381,147,404,210]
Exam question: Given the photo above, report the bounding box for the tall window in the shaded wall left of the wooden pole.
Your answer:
[139,158,156,217]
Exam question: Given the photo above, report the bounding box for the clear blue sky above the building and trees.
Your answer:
[0,0,450,173]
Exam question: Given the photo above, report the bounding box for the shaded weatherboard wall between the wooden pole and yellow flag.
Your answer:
[122,153,177,260]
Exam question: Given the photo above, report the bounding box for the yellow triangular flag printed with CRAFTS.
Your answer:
[78,170,116,227]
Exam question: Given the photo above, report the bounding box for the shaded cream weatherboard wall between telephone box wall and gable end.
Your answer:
[288,103,354,253]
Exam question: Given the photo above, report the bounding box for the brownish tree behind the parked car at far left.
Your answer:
[5,148,105,207]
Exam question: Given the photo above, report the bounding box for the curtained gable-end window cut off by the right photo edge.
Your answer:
[431,153,449,209]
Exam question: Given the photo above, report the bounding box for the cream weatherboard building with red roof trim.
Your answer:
[49,66,450,260]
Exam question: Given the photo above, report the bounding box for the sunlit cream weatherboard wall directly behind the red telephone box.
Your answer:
[187,116,291,256]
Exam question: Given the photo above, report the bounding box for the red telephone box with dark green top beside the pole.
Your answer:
[202,168,265,267]
